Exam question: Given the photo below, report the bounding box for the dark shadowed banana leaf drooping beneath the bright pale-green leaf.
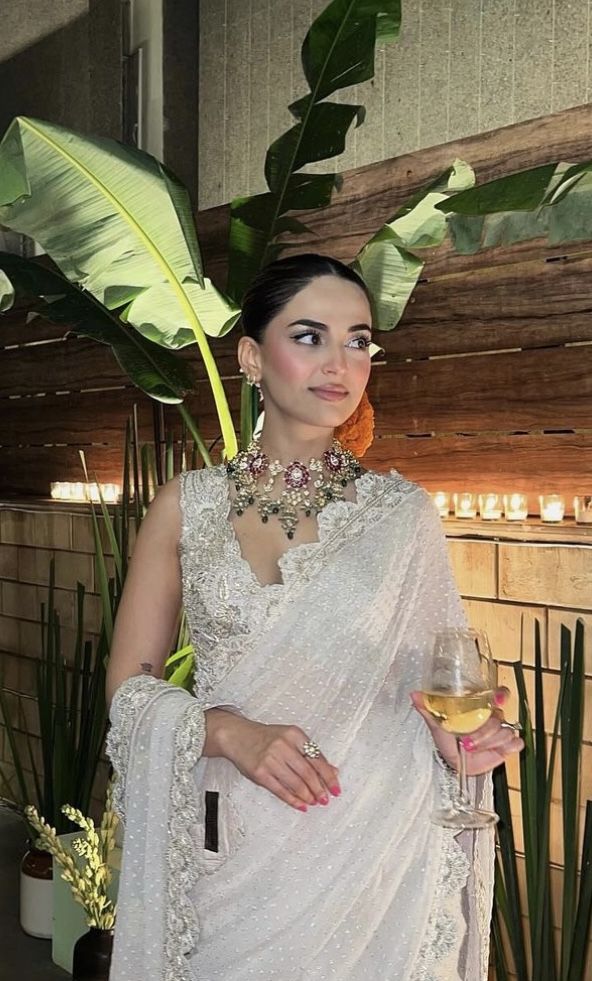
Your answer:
[0,252,195,403]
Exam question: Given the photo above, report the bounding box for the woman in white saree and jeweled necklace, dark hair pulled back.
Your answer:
[107,255,522,981]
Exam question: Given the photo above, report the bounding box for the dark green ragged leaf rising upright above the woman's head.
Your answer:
[228,0,401,303]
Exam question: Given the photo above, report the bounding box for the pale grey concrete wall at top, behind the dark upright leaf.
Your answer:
[199,0,592,208]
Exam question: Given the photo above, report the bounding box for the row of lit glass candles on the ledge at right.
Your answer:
[432,491,592,525]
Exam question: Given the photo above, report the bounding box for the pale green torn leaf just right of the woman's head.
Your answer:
[353,160,475,330]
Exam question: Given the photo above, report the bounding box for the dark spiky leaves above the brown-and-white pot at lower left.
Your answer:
[0,560,108,841]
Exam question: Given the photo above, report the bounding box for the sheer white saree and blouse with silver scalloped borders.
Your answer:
[108,467,493,981]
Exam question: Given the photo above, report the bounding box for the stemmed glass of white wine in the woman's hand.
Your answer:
[422,627,499,830]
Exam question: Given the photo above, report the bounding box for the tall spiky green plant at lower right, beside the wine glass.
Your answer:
[492,620,592,981]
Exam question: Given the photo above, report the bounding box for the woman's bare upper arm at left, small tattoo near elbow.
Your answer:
[105,478,181,706]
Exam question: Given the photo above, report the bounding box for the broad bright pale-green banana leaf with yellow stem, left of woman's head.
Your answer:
[0,117,238,456]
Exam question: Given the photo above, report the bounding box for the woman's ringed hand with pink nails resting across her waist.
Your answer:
[204,709,341,811]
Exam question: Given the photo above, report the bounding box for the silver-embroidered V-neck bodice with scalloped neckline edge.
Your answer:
[179,466,417,708]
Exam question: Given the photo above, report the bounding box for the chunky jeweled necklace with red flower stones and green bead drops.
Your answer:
[226,438,363,538]
